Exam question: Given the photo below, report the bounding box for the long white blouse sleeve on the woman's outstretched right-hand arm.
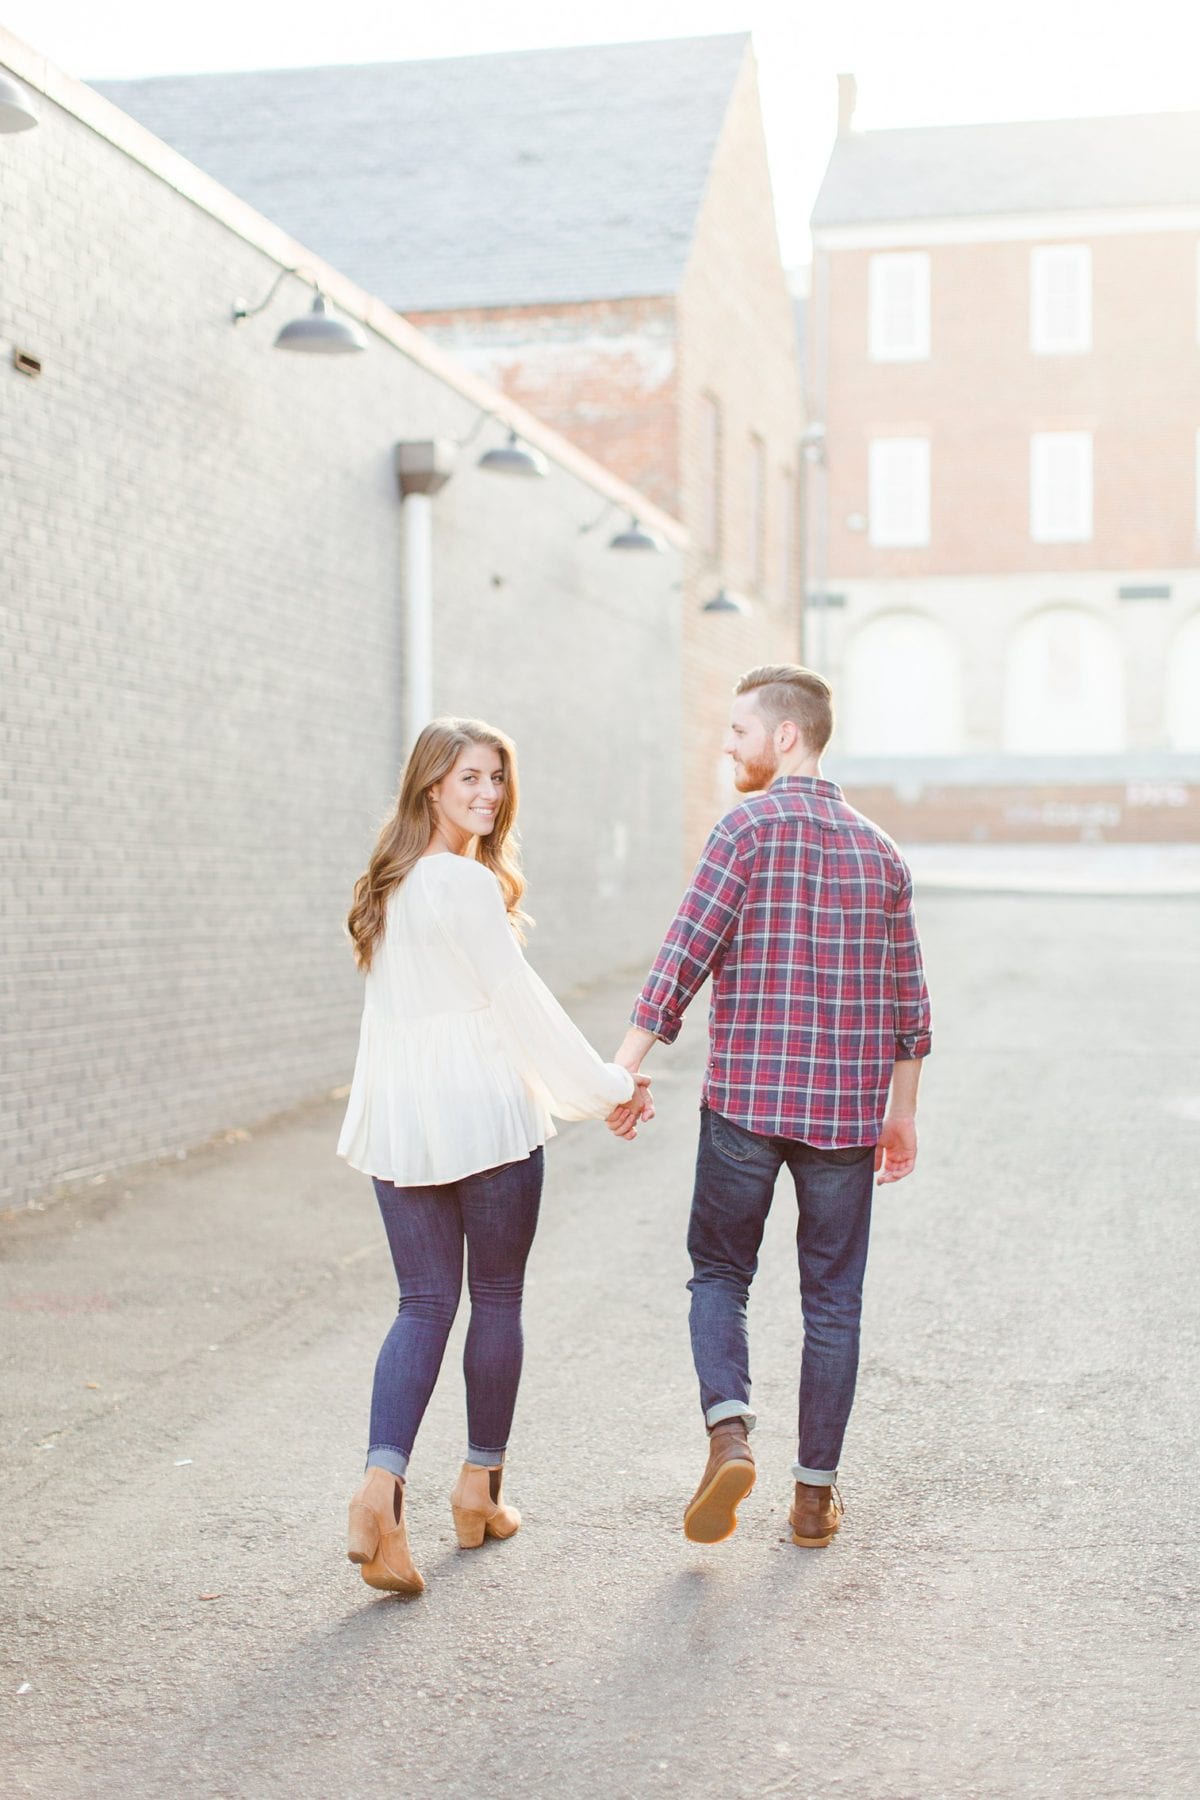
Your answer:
[439,862,635,1120]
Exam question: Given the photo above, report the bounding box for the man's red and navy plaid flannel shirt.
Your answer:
[633,776,930,1150]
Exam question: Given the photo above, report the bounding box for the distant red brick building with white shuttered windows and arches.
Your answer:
[808,89,1200,802]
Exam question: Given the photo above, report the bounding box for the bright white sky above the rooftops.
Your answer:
[0,0,1200,266]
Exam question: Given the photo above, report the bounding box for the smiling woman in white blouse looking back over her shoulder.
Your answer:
[338,718,653,1593]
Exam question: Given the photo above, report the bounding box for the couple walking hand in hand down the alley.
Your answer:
[338,664,930,1593]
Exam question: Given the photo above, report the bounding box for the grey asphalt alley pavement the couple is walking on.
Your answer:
[0,889,1200,1800]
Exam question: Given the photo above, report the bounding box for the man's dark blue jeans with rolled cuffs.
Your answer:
[687,1107,874,1483]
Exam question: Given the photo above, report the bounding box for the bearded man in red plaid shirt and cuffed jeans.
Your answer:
[617,662,930,1548]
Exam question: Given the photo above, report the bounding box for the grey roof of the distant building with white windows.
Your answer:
[813,112,1200,230]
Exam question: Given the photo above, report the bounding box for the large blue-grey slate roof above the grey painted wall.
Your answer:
[95,32,750,311]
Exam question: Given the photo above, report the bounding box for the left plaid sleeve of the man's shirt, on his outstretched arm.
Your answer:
[630,824,747,1044]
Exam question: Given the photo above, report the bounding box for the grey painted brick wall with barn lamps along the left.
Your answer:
[0,59,680,1202]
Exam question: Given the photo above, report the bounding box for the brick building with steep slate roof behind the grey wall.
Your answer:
[103,36,801,850]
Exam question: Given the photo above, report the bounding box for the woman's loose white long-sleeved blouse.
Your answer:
[338,853,633,1188]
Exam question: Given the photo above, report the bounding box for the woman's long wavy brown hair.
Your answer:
[345,718,527,970]
